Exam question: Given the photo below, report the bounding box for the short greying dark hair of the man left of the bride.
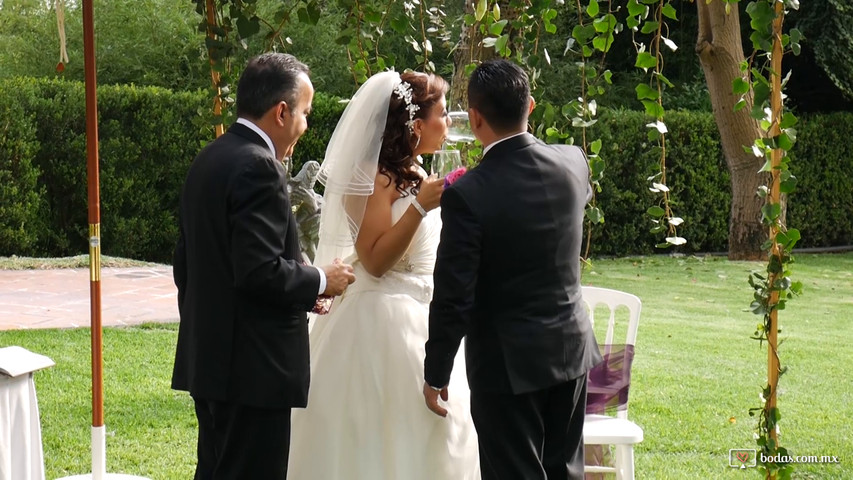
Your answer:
[237,53,309,120]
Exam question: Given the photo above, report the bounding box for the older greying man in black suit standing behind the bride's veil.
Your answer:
[172,53,355,480]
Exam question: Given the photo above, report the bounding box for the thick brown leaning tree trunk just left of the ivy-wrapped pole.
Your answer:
[696,0,769,260]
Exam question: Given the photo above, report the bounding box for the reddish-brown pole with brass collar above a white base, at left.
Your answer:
[83,0,104,427]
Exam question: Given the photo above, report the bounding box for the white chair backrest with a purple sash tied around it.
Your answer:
[581,286,642,419]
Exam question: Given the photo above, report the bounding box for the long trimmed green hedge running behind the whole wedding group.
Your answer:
[0,78,853,262]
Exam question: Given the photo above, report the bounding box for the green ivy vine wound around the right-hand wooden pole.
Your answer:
[727,0,803,479]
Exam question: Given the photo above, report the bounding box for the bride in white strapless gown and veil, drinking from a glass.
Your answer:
[288,72,480,480]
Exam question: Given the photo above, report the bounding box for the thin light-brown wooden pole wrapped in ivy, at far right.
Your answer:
[765,2,784,479]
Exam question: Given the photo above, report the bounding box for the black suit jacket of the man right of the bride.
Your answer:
[425,134,601,394]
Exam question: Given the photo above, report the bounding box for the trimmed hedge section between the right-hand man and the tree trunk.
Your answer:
[587,111,731,256]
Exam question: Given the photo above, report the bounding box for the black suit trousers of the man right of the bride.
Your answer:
[471,375,587,480]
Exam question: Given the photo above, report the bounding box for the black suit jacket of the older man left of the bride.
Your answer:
[172,123,320,408]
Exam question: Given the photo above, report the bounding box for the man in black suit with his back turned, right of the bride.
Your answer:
[423,60,601,480]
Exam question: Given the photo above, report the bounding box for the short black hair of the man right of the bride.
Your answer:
[468,59,530,133]
